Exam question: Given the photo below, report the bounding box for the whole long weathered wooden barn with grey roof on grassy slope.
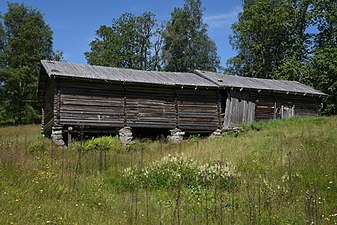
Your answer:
[38,60,326,144]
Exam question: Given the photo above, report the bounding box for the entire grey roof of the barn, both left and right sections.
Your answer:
[41,60,327,97]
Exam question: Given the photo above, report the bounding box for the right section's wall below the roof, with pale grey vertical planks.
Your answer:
[222,91,321,128]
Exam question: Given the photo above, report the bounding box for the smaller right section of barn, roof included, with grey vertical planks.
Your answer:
[196,71,327,128]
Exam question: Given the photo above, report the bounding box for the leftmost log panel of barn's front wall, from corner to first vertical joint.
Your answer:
[58,81,124,127]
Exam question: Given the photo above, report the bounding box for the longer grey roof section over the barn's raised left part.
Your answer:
[41,60,218,88]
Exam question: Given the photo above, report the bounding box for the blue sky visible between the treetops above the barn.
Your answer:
[0,0,242,66]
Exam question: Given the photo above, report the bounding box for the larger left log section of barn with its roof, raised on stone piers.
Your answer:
[39,61,221,142]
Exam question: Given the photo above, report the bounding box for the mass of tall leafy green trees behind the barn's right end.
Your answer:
[226,0,337,114]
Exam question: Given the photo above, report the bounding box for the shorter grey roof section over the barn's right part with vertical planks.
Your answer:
[196,71,327,97]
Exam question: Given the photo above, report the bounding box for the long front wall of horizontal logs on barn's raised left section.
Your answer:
[46,79,221,131]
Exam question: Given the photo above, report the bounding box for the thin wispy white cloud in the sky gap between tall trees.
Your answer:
[204,7,242,30]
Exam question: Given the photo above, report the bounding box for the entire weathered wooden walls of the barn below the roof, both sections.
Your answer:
[42,79,321,134]
